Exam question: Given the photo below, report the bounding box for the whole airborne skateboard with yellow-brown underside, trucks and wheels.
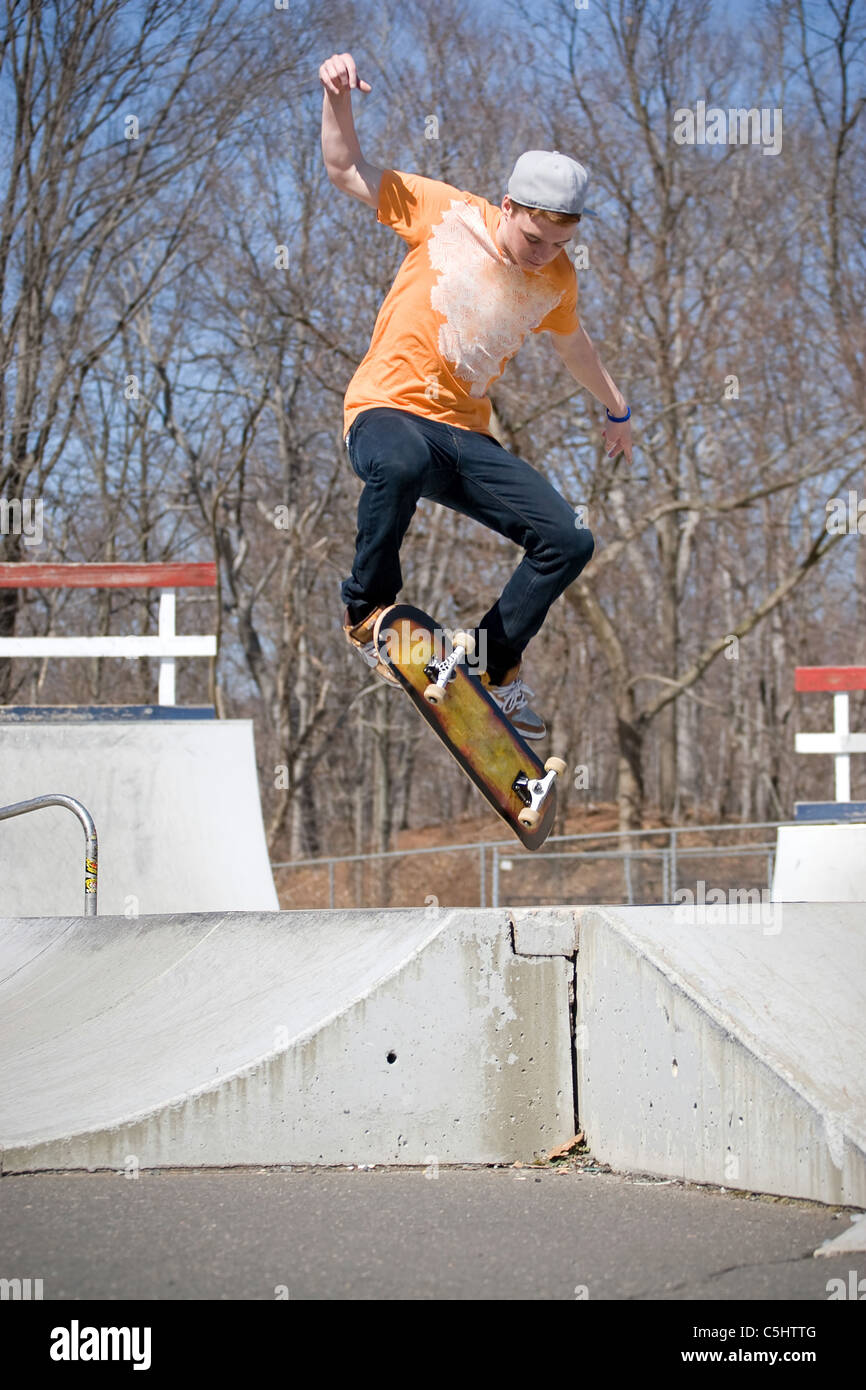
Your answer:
[373,603,566,849]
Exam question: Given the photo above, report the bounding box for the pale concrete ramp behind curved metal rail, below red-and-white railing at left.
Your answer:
[0,719,279,917]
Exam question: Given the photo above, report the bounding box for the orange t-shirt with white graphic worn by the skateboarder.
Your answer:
[343,170,578,434]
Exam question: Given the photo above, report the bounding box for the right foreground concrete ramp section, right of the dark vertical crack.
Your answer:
[575,904,866,1205]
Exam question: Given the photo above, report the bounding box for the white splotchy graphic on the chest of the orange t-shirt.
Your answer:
[427,200,562,398]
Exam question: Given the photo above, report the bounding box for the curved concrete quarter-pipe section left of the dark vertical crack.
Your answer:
[0,909,574,1172]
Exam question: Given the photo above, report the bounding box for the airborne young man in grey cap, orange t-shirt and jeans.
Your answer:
[318,53,631,738]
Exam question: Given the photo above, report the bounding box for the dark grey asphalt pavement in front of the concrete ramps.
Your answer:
[0,1165,866,1302]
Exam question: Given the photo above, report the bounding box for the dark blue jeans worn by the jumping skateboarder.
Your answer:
[342,407,594,677]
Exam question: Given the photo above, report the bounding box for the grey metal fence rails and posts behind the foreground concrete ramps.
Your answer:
[271,820,806,908]
